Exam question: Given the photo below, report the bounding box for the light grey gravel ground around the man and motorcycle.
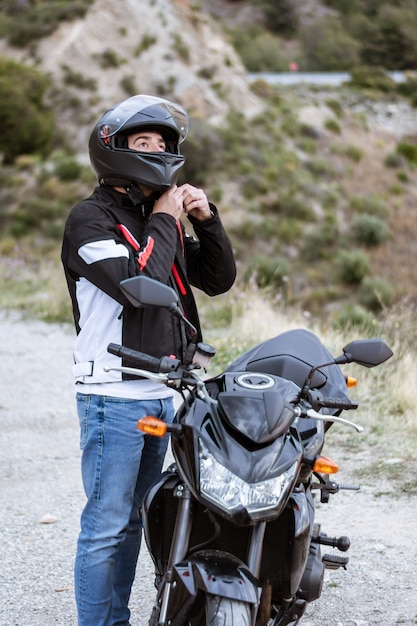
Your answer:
[0,312,417,626]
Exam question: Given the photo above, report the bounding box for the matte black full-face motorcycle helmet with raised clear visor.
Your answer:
[89,95,188,191]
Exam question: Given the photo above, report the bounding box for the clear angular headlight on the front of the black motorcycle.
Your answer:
[199,440,298,519]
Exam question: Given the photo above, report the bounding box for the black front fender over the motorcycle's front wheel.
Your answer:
[167,550,260,625]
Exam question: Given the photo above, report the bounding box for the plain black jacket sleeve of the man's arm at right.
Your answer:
[184,204,236,296]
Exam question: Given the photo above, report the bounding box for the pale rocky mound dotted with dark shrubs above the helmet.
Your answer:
[0,0,260,151]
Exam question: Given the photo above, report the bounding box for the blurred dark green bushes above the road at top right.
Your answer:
[224,0,417,72]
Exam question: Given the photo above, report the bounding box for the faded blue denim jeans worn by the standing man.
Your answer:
[74,393,174,626]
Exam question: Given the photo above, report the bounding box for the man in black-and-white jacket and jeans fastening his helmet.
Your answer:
[62,95,236,626]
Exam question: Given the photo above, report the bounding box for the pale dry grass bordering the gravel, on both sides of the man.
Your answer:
[0,234,417,493]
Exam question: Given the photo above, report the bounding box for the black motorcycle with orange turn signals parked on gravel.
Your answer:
[108,277,392,626]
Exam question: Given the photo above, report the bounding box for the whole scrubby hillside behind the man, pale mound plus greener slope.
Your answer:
[0,0,417,314]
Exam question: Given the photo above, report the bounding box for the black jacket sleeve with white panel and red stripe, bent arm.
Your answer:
[62,203,178,305]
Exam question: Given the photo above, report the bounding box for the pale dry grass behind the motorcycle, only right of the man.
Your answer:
[203,291,417,493]
